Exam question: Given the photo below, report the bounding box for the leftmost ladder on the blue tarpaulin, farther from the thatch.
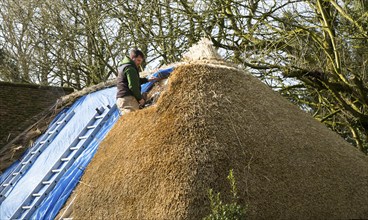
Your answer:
[0,111,75,204]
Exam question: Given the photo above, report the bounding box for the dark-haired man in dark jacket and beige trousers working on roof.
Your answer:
[116,49,157,115]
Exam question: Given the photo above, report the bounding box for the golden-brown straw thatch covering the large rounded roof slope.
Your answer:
[67,62,368,219]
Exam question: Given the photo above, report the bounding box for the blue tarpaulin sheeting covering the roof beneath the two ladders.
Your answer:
[0,67,174,220]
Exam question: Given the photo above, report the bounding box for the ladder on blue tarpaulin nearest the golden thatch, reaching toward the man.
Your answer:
[11,105,116,219]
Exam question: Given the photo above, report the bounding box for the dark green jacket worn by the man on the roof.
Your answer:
[116,57,148,101]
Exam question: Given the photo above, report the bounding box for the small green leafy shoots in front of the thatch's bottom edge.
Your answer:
[204,169,247,220]
